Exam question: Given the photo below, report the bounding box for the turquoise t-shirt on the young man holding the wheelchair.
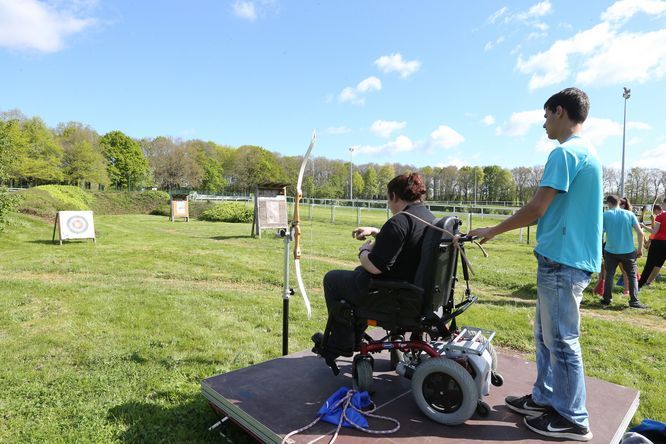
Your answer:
[534,136,603,272]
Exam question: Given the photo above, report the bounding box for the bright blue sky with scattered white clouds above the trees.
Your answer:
[0,0,666,169]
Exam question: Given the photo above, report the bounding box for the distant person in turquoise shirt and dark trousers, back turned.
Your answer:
[601,194,647,308]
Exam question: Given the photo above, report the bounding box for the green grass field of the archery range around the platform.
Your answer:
[0,208,666,442]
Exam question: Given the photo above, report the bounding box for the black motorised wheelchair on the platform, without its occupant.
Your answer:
[312,216,504,425]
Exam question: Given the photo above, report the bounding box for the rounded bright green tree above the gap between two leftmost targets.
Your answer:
[100,131,150,190]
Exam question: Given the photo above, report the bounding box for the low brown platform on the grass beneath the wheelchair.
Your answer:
[201,344,639,444]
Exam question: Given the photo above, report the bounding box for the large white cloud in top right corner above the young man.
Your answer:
[516,0,666,90]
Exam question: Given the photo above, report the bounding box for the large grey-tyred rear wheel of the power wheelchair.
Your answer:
[412,358,479,425]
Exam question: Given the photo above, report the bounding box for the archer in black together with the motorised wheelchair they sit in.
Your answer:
[312,174,503,425]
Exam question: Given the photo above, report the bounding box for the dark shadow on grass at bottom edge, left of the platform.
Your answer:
[107,392,255,443]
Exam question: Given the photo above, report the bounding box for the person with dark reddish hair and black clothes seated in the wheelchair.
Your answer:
[313,173,435,372]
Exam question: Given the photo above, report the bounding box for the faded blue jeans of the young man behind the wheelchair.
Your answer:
[532,253,591,427]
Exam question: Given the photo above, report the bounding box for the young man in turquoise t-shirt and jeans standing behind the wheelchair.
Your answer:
[469,88,603,441]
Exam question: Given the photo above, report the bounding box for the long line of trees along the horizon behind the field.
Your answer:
[0,110,666,202]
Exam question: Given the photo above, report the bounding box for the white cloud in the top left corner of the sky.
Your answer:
[0,0,96,53]
